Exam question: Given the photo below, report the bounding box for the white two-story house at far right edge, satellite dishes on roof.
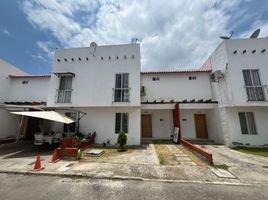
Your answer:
[206,38,268,146]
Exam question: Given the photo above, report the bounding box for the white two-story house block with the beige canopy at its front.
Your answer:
[47,43,141,145]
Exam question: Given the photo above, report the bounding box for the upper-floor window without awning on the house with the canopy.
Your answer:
[114,73,130,102]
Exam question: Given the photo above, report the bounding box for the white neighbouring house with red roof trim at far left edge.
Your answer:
[0,60,50,139]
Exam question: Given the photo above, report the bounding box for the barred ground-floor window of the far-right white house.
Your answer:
[238,112,257,135]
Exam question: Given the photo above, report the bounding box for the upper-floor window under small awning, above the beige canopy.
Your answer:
[57,76,73,103]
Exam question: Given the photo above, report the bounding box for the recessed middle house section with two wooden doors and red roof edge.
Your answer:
[141,68,217,139]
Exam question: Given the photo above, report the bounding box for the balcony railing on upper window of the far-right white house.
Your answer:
[245,85,265,101]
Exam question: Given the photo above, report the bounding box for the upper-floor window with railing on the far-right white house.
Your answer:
[243,69,265,101]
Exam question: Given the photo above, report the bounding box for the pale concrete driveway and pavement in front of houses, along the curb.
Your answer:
[0,142,251,183]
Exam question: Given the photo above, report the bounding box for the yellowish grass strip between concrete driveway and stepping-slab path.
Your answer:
[154,142,180,165]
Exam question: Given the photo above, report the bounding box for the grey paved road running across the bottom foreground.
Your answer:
[0,174,268,200]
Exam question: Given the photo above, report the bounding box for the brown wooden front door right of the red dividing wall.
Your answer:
[194,114,208,138]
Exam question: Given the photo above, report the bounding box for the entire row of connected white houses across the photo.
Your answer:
[0,38,268,146]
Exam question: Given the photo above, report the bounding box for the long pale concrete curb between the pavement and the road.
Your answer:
[0,170,253,186]
